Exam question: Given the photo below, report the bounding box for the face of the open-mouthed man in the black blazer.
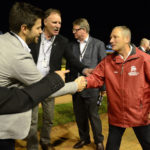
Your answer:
[44,12,61,36]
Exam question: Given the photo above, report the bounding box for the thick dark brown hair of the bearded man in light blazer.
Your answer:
[9,2,43,34]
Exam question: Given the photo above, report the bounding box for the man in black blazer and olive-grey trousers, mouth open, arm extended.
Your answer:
[27,9,90,150]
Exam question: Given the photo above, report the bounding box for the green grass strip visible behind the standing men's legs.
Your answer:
[38,96,107,129]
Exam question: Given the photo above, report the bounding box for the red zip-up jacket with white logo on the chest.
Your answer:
[86,47,150,127]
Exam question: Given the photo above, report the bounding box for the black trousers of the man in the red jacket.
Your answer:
[106,125,150,150]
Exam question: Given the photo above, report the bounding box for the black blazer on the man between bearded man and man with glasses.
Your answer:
[29,35,85,72]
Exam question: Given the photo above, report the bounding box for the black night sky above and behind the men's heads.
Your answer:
[0,0,150,46]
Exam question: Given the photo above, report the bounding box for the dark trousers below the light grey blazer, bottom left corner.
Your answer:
[0,139,15,150]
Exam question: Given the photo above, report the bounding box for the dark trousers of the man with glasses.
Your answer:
[73,93,104,144]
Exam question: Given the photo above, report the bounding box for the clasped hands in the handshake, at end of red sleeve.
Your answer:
[75,76,87,92]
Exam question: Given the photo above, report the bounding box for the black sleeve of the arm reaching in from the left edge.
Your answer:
[0,73,64,115]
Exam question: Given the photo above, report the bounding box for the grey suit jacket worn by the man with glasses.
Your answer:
[67,36,106,97]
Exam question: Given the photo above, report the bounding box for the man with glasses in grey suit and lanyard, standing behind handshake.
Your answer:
[67,18,106,150]
